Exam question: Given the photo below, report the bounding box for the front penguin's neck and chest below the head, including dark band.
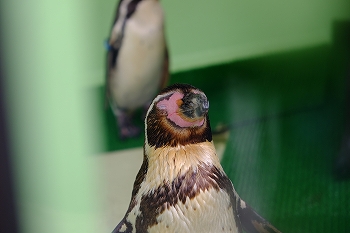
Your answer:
[121,142,239,233]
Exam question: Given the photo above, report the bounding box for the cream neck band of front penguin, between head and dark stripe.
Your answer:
[144,141,222,188]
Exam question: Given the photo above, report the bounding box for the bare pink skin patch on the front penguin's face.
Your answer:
[157,92,204,127]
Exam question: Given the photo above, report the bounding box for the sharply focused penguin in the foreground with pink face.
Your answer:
[113,84,280,233]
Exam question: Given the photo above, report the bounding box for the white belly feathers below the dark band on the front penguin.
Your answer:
[148,189,238,233]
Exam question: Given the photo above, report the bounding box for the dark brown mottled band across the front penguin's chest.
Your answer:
[136,163,241,232]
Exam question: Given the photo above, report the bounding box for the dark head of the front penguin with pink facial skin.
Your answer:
[145,84,212,148]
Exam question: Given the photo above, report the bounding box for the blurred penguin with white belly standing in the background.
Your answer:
[106,0,169,138]
